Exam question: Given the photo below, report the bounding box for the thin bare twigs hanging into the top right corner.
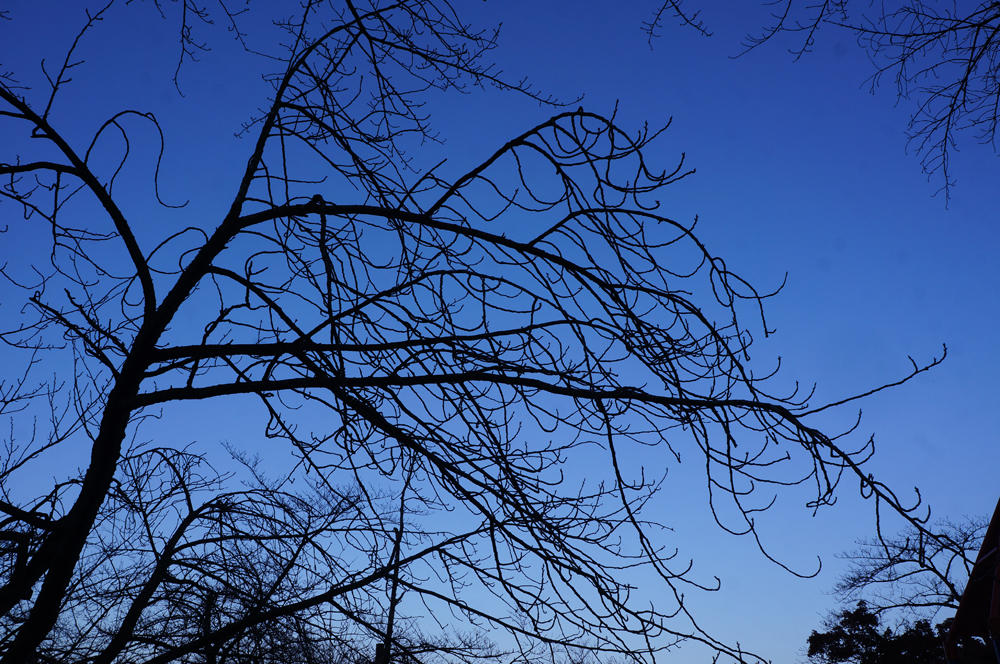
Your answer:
[646,0,1000,197]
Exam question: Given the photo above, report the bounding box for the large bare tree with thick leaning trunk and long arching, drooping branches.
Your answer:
[0,0,938,664]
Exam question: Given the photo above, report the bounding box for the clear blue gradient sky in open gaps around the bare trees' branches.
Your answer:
[0,0,1000,664]
